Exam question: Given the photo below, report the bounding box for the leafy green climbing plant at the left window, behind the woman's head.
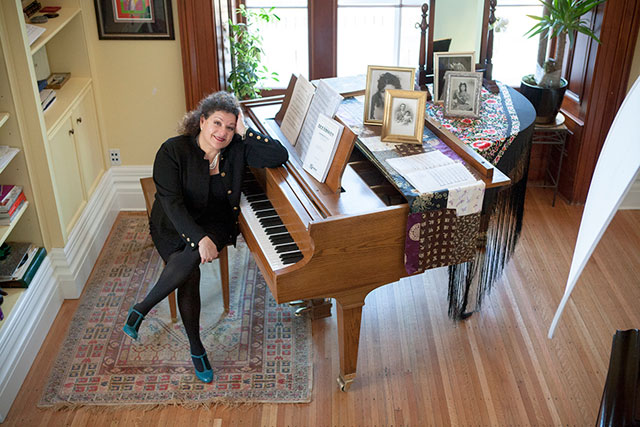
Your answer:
[227,4,280,99]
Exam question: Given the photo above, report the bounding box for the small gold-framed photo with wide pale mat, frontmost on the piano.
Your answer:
[380,89,427,144]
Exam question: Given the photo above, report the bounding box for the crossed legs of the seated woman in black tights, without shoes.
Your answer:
[131,247,204,356]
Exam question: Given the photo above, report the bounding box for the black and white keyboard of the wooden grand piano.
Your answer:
[240,182,303,271]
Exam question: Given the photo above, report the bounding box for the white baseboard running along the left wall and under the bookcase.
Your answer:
[0,166,152,422]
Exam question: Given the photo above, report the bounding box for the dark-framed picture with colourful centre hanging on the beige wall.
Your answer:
[94,0,174,40]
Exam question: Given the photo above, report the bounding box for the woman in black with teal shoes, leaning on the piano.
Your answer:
[123,92,288,383]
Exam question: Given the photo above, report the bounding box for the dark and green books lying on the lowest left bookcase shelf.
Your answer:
[0,242,47,288]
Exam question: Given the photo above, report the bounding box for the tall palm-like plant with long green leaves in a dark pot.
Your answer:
[525,0,605,88]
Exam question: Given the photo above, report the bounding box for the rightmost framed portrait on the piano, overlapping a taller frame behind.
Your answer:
[444,71,482,118]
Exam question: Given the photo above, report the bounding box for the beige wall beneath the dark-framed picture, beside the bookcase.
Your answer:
[82,0,185,166]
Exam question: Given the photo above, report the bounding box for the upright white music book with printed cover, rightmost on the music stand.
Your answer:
[302,114,344,182]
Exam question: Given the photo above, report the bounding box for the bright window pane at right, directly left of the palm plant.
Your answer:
[492,0,542,87]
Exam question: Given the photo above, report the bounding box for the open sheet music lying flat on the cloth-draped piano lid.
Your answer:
[387,151,477,193]
